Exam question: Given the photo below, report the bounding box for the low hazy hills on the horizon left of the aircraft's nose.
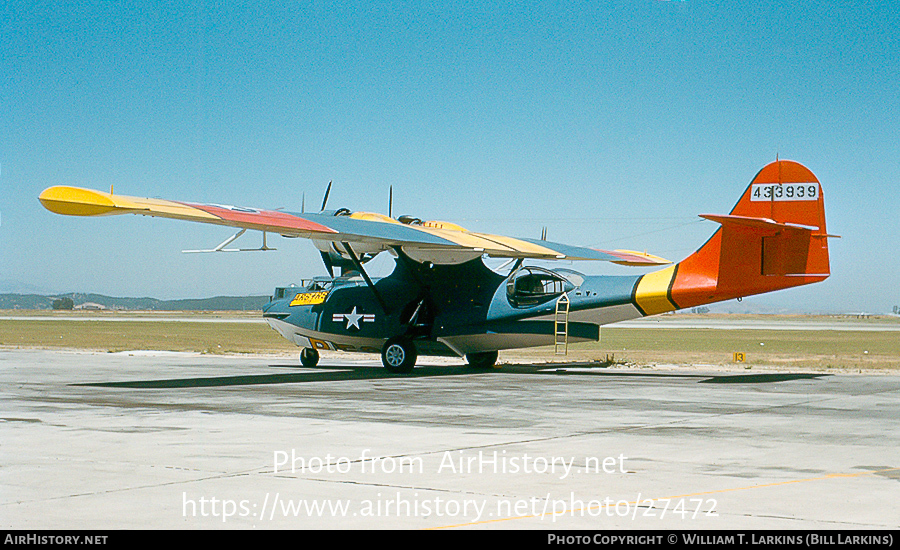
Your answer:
[0,292,269,311]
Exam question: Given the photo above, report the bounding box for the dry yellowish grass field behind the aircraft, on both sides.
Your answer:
[0,311,900,372]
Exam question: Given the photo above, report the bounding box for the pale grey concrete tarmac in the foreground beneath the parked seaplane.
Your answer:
[0,350,900,530]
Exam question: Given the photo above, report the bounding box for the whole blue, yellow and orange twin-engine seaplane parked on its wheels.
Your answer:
[39,160,833,374]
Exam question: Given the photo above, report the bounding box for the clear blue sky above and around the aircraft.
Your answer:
[0,0,900,312]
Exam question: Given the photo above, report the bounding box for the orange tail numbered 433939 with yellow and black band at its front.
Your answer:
[637,160,830,315]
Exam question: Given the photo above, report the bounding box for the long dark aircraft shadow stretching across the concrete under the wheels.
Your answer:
[72,363,831,389]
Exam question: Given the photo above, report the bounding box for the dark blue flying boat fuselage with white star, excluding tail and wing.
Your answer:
[263,259,641,355]
